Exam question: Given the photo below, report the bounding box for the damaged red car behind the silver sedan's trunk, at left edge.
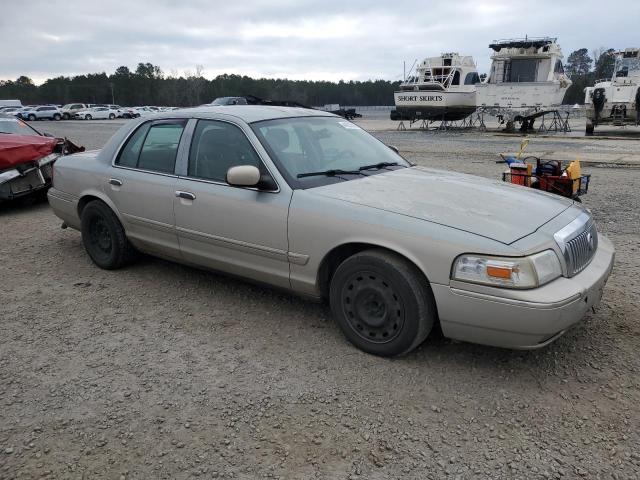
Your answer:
[0,114,84,202]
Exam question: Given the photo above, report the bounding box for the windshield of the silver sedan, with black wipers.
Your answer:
[251,117,411,188]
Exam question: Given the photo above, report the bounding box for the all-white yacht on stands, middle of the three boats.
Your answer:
[476,37,571,113]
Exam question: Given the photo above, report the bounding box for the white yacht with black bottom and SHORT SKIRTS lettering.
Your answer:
[391,53,480,121]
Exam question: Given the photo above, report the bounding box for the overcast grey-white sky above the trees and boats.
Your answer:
[0,0,640,83]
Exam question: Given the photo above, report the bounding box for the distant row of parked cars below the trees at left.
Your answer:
[0,103,178,121]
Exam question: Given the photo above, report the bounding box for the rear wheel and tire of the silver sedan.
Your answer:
[80,200,137,270]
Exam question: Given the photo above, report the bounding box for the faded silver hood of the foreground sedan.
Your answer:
[308,167,573,244]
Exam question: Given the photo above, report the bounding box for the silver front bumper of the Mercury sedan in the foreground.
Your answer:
[431,235,615,349]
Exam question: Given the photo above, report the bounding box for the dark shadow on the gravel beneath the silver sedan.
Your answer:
[131,256,603,376]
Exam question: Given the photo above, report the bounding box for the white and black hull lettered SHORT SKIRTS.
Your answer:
[393,91,476,121]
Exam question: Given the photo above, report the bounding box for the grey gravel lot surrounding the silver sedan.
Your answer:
[0,121,640,479]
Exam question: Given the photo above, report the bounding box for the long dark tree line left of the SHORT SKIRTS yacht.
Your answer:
[0,63,400,107]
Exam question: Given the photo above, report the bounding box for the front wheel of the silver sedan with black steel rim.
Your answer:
[329,250,436,357]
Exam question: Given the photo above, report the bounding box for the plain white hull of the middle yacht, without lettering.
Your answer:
[476,81,571,110]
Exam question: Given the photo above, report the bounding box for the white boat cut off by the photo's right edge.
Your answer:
[584,48,640,135]
